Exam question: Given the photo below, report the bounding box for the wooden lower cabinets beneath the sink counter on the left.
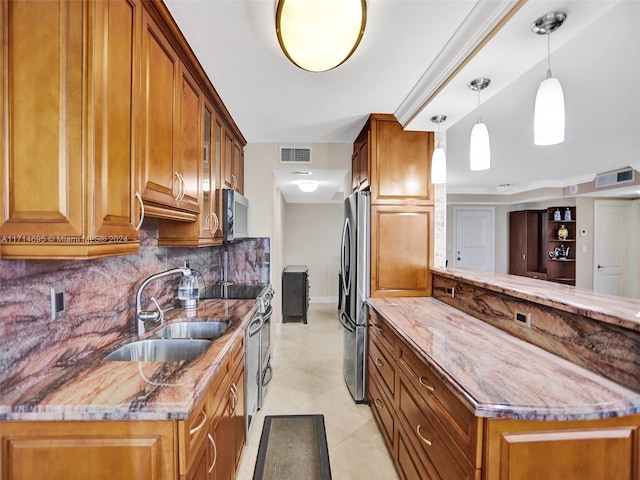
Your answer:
[0,337,246,480]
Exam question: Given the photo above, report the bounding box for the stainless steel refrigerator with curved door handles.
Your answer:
[340,191,371,403]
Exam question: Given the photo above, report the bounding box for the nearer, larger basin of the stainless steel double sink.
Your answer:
[104,338,211,362]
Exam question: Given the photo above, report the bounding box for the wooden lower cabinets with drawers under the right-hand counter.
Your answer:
[367,310,640,480]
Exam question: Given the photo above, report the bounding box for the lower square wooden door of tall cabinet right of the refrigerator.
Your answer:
[370,205,433,297]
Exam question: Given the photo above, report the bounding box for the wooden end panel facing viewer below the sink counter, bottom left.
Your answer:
[0,421,177,480]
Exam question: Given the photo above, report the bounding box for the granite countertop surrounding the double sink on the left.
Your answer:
[0,300,258,420]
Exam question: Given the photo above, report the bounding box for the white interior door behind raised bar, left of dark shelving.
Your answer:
[453,206,495,272]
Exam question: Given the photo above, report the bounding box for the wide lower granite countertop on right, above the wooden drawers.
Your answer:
[368,296,640,420]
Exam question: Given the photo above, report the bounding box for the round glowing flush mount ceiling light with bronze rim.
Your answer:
[276,0,367,72]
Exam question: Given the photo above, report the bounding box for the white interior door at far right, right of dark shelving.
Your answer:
[593,200,635,297]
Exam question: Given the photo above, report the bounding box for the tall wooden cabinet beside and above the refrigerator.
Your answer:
[352,114,434,297]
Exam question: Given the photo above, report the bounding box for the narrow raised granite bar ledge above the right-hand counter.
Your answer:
[432,268,640,332]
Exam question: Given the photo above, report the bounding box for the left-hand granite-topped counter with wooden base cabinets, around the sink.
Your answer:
[0,300,258,480]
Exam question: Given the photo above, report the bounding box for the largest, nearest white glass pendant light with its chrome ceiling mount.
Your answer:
[531,12,567,145]
